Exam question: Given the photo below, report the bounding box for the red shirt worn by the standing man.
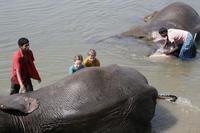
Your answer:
[11,49,40,84]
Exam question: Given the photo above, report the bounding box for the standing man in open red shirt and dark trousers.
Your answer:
[10,38,41,95]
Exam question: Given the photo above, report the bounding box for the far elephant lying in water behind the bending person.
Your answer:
[122,2,200,42]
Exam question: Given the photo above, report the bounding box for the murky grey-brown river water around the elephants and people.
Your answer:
[0,0,200,133]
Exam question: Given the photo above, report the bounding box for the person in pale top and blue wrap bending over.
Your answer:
[159,27,196,60]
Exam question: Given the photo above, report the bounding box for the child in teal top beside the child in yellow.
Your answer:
[69,55,85,74]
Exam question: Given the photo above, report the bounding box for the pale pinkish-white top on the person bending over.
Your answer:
[168,29,189,44]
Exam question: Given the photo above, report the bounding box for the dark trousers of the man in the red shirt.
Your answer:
[10,79,33,95]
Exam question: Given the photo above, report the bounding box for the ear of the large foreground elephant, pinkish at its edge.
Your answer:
[0,95,39,114]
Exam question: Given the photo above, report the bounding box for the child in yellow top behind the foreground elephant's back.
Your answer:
[83,49,100,67]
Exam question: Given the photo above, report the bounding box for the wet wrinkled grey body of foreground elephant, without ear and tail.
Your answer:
[0,65,157,133]
